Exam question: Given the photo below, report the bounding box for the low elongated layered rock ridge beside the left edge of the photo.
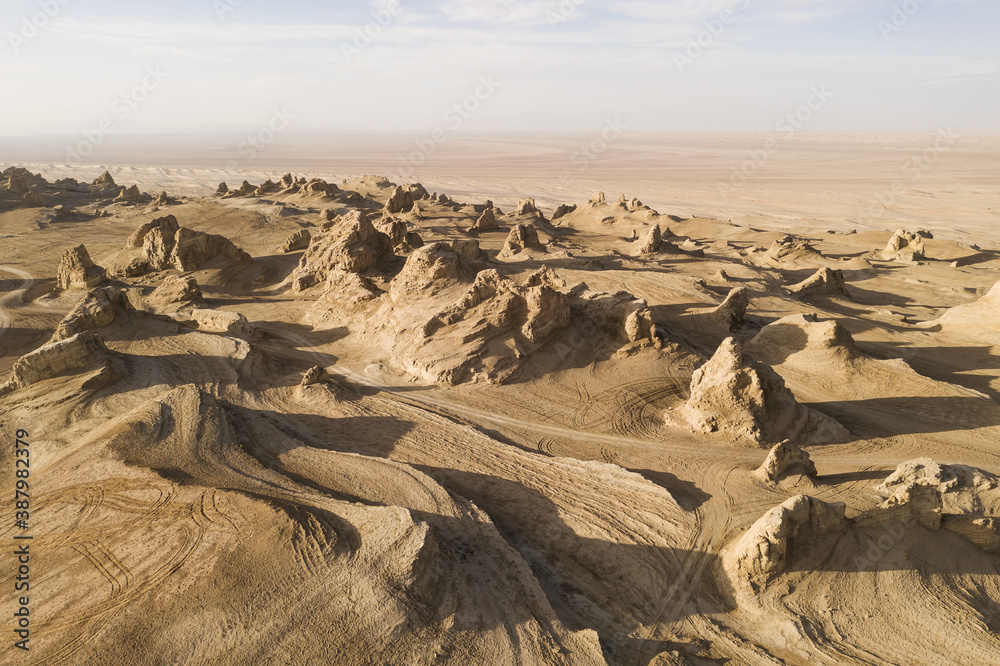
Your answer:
[0,331,120,397]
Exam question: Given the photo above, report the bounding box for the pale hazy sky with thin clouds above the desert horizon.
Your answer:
[0,0,1000,137]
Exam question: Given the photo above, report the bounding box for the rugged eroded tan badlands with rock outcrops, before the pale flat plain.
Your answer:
[0,162,1000,666]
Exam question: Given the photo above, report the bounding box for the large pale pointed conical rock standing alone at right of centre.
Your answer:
[667,338,849,446]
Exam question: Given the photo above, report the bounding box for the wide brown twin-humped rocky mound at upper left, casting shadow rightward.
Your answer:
[110,215,253,277]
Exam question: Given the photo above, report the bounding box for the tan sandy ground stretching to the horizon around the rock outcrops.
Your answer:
[0,135,1000,665]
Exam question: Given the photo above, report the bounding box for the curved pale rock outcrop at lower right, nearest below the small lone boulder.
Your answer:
[722,495,847,592]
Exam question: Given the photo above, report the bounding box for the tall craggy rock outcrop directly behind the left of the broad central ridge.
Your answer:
[292,211,393,291]
